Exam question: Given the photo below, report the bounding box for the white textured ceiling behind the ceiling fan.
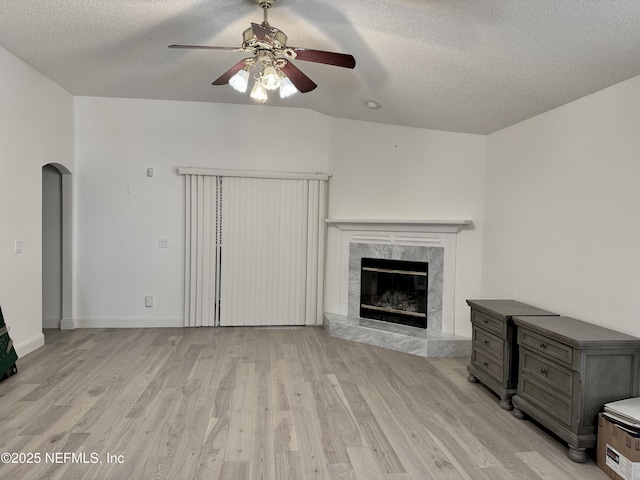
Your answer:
[0,0,640,133]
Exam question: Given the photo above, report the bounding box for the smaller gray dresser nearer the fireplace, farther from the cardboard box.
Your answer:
[467,300,558,410]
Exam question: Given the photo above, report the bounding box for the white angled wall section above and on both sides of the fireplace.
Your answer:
[325,119,486,336]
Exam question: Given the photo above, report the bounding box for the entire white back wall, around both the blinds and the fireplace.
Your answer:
[74,97,485,334]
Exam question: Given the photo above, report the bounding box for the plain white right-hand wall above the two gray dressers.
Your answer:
[483,77,640,336]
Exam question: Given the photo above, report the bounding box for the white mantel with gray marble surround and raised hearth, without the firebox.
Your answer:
[324,219,471,357]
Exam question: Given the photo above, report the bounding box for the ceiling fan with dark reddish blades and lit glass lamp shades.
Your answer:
[169,0,356,103]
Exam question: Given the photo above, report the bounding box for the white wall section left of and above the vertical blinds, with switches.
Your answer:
[74,97,329,327]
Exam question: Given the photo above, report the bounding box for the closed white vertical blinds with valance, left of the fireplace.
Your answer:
[178,169,328,326]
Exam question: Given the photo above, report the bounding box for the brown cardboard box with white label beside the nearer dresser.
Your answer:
[596,414,640,480]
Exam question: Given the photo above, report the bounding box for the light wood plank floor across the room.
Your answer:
[0,327,608,480]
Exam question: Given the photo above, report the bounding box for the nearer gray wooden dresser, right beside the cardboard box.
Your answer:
[512,316,640,462]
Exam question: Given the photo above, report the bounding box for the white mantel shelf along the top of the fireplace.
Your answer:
[325,218,473,233]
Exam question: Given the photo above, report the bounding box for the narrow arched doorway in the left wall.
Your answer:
[42,164,73,328]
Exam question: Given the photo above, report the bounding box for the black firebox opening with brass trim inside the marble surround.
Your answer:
[360,258,429,328]
